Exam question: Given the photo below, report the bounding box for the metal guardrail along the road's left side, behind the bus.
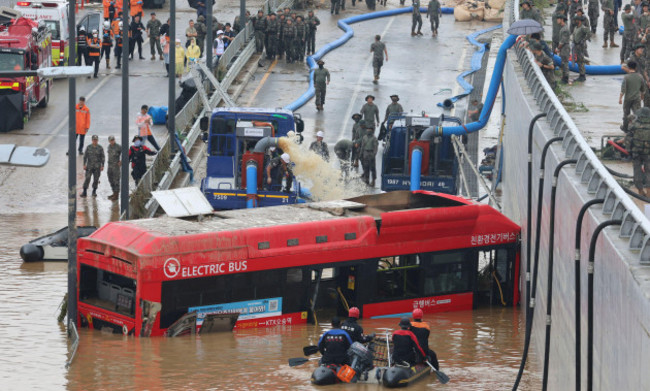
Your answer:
[129,0,294,219]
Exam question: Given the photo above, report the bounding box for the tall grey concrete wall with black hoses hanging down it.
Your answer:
[502,45,650,390]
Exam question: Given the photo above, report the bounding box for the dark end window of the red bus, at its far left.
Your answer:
[79,264,135,318]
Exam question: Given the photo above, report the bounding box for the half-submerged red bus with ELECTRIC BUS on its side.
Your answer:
[77,191,520,336]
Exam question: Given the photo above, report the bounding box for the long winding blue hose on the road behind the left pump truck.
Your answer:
[284,7,454,111]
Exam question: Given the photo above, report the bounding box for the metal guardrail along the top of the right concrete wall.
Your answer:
[504,1,650,264]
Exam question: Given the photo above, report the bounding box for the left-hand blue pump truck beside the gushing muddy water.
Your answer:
[201,108,304,210]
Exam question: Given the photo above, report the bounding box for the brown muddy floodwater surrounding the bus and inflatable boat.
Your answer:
[0,212,540,390]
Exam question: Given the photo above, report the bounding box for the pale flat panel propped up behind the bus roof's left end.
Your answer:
[151,187,212,217]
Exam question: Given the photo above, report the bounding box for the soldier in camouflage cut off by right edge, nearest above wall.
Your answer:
[630,107,650,197]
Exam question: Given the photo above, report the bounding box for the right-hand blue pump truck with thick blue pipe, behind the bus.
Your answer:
[381,114,461,194]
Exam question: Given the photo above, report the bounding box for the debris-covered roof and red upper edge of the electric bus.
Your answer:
[79,191,520,268]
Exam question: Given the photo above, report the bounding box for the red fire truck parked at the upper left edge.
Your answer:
[0,11,52,131]
